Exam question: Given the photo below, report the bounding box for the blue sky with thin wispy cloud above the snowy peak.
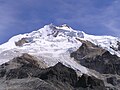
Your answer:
[0,0,120,44]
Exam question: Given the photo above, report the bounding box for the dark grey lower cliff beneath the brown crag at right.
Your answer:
[72,51,120,75]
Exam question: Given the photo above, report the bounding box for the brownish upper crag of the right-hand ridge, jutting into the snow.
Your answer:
[71,39,106,60]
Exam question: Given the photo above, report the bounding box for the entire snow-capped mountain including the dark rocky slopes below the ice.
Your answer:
[0,24,120,90]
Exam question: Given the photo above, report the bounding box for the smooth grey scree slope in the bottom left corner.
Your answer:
[0,78,57,90]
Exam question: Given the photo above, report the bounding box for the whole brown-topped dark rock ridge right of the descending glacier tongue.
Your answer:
[71,41,120,90]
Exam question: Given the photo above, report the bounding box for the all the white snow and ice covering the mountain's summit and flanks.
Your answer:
[0,24,120,74]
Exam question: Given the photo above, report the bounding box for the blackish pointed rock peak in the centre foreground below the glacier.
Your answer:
[34,63,77,86]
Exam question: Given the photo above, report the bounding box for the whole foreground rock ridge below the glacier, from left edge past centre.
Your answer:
[0,55,105,90]
